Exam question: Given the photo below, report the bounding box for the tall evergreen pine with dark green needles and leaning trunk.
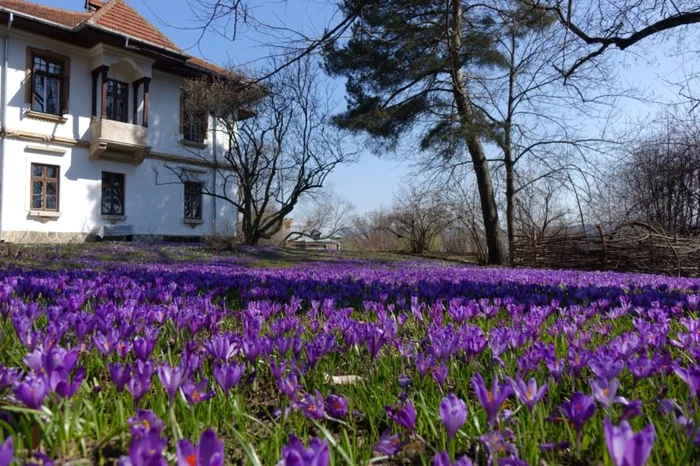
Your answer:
[325,0,508,264]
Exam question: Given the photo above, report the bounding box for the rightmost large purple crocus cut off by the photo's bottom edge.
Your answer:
[603,417,656,466]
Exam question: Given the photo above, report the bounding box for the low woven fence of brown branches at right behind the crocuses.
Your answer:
[514,222,700,277]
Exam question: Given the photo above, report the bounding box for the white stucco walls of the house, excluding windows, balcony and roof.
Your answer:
[2,31,236,237]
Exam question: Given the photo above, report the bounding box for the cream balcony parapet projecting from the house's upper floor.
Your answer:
[90,118,151,165]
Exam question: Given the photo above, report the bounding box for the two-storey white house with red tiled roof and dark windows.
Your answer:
[0,0,236,243]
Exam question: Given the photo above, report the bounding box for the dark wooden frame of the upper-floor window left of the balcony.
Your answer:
[24,47,70,117]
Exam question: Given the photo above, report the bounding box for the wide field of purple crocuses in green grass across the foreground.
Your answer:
[0,248,700,466]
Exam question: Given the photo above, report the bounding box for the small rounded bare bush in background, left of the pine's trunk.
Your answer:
[388,186,455,254]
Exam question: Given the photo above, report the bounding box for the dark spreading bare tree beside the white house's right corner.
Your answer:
[174,58,353,244]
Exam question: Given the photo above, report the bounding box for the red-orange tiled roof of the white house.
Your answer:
[0,0,229,74]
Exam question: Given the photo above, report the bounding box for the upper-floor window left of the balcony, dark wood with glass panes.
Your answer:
[28,51,69,116]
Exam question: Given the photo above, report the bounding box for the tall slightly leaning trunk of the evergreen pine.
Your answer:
[449,0,507,265]
